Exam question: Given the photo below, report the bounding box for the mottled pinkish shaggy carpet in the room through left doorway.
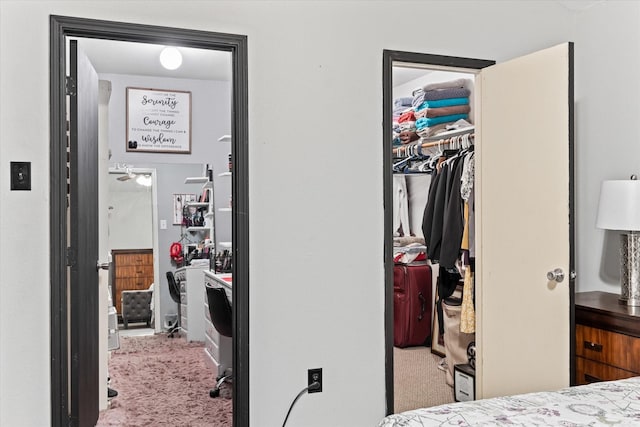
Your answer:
[96,334,232,427]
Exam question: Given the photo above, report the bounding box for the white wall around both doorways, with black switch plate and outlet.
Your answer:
[0,1,584,427]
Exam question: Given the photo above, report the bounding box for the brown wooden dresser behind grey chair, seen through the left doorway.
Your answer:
[111,249,153,316]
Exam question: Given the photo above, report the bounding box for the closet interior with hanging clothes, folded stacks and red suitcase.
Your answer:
[387,64,476,410]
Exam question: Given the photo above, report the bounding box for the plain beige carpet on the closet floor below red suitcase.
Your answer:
[393,347,454,412]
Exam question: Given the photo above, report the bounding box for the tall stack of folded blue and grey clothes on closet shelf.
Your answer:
[412,79,471,138]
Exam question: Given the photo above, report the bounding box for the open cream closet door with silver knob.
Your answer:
[476,44,573,398]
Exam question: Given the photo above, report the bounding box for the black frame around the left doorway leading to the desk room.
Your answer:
[49,15,249,427]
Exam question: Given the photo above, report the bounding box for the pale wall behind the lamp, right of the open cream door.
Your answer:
[575,1,640,293]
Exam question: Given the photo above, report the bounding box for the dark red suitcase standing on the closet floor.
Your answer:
[393,263,432,347]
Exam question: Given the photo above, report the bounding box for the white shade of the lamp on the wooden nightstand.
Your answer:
[596,179,640,231]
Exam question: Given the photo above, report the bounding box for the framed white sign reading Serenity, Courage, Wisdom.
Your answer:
[126,87,191,154]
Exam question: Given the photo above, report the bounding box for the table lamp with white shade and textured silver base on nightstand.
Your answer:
[596,175,640,306]
